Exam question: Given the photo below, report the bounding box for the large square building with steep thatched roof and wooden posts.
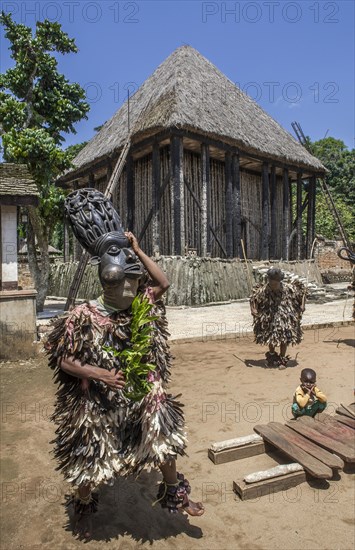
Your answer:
[59,46,325,258]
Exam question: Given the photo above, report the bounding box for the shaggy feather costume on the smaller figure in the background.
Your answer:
[250,281,307,346]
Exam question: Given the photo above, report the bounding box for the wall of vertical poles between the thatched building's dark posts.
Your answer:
[94,145,284,260]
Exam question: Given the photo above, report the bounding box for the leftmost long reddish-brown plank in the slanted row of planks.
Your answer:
[254,424,333,479]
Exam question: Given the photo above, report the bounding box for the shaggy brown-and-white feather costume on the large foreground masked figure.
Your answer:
[46,301,186,488]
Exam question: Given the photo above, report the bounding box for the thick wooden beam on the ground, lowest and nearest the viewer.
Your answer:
[233,471,307,500]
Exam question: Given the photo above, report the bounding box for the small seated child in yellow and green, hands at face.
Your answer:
[292,369,327,418]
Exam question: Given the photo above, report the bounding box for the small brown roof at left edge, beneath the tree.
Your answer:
[0,162,39,206]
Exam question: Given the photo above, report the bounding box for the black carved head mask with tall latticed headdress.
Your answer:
[65,189,143,288]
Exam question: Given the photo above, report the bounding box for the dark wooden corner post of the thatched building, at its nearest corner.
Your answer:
[170,136,185,256]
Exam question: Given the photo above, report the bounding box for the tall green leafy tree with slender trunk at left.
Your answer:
[0,12,89,311]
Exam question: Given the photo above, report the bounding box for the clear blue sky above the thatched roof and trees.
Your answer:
[0,0,354,148]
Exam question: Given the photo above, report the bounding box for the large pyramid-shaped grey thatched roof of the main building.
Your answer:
[62,46,325,180]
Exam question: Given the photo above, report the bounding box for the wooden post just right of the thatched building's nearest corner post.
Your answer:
[201,143,211,258]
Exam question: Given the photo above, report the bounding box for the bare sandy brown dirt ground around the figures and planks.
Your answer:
[0,327,355,550]
